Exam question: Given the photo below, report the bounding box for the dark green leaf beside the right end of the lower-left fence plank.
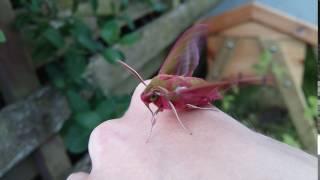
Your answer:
[66,89,90,112]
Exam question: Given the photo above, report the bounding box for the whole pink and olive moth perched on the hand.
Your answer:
[118,24,257,141]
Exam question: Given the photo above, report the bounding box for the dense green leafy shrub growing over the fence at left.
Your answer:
[13,0,164,153]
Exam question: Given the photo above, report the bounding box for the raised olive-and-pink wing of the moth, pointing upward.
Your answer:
[159,24,207,76]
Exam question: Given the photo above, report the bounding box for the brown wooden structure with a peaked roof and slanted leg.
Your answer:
[204,2,318,153]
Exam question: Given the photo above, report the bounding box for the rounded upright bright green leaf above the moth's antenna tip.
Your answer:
[100,20,120,45]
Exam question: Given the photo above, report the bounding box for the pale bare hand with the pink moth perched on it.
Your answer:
[68,84,317,180]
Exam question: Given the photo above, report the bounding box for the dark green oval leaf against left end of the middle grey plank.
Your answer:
[64,50,87,82]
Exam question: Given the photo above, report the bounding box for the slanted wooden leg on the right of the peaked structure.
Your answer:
[261,41,317,154]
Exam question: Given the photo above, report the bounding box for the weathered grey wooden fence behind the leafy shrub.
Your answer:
[0,0,218,180]
